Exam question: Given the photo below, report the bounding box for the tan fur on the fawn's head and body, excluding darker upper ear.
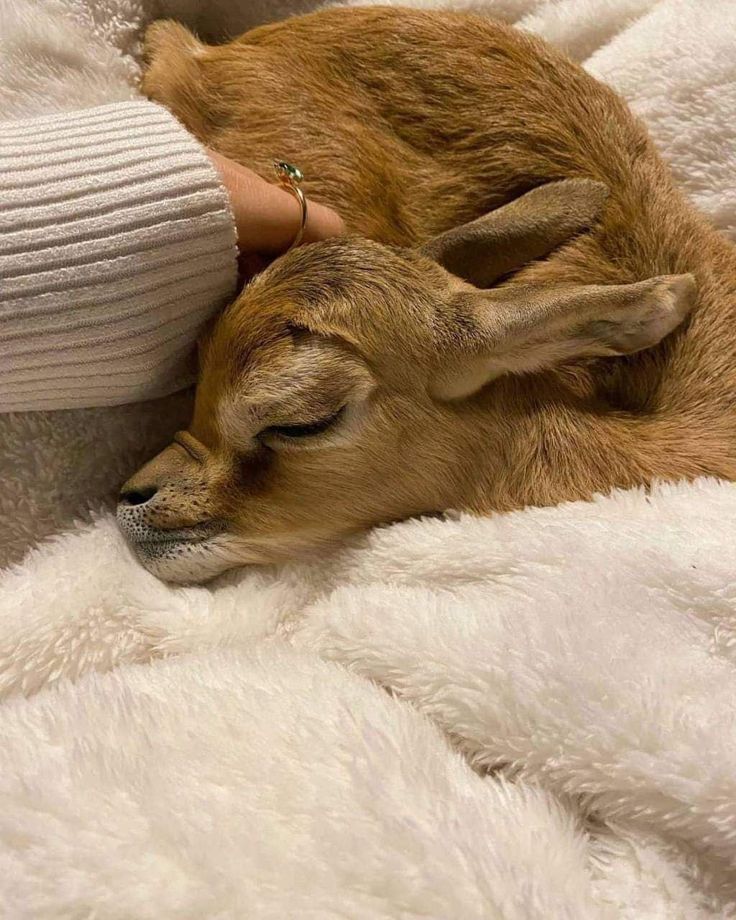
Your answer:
[123,8,736,580]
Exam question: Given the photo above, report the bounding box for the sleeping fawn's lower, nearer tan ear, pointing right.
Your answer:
[431,275,695,399]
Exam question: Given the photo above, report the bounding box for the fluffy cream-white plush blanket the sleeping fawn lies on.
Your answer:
[0,0,736,920]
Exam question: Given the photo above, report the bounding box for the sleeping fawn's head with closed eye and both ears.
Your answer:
[118,180,693,582]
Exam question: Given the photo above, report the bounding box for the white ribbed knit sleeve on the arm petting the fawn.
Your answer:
[0,100,237,412]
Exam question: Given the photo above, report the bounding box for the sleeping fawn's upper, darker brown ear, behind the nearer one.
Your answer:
[420,179,608,288]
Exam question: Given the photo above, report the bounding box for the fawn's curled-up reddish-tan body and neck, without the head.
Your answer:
[145,8,736,510]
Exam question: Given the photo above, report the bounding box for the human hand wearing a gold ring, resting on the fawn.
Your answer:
[207,150,345,273]
